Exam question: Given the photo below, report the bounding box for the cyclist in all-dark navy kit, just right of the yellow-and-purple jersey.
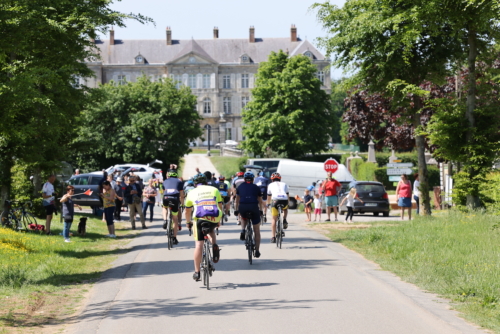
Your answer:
[234,172,263,258]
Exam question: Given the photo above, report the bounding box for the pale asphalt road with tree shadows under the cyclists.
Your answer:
[68,208,483,334]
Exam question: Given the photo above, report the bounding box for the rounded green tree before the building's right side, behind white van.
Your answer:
[243,51,336,158]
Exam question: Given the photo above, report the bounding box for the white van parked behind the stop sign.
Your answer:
[277,160,356,209]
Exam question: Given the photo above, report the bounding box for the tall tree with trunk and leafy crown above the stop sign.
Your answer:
[313,0,457,214]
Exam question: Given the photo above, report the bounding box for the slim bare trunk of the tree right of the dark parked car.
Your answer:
[413,101,431,216]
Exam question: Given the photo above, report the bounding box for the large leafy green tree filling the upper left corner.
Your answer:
[0,0,150,207]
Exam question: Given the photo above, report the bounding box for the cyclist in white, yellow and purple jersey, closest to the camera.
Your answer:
[185,174,222,281]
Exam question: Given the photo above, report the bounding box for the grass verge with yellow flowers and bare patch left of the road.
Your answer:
[0,214,136,333]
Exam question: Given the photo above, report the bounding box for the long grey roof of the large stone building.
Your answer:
[96,37,325,65]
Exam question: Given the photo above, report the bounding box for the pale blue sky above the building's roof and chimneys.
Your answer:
[108,0,345,79]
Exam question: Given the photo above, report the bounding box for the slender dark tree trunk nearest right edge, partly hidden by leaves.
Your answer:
[464,28,480,209]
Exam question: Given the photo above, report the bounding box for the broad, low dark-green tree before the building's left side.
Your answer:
[73,76,202,170]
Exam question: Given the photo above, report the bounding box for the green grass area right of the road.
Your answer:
[320,210,500,333]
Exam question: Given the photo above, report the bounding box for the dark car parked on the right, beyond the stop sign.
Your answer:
[339,181,390,217]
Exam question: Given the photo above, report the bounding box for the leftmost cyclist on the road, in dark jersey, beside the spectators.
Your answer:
[163,169,184,245]
